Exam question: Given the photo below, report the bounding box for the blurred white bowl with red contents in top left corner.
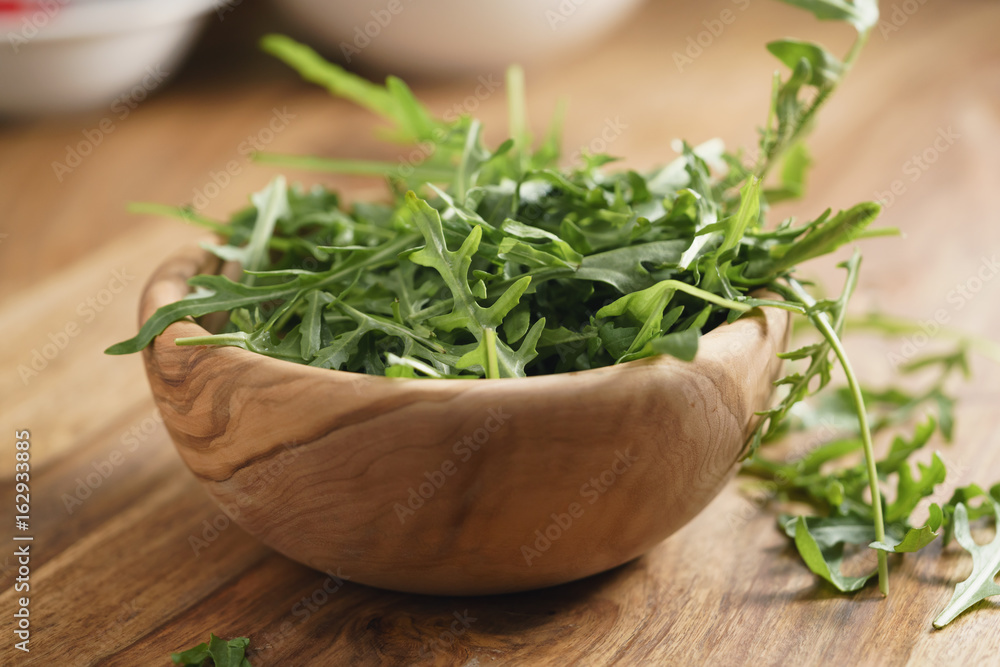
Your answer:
[0,0,231,116]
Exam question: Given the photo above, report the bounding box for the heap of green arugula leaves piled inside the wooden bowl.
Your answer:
[108,3,892,380]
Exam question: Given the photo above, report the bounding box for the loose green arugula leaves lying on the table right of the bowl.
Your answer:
[742,342,1000,627]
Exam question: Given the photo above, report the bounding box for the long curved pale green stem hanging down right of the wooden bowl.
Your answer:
[788,279,889,596]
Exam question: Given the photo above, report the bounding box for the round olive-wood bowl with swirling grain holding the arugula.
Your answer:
[140,248,788,595]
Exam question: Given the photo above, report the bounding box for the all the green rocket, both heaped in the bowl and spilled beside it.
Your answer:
[108,0,1000,625]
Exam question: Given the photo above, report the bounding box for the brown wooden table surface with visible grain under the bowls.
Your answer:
[0,0,1000,667]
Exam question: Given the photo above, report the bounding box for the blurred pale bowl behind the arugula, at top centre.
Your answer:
[275,0,642,75]
